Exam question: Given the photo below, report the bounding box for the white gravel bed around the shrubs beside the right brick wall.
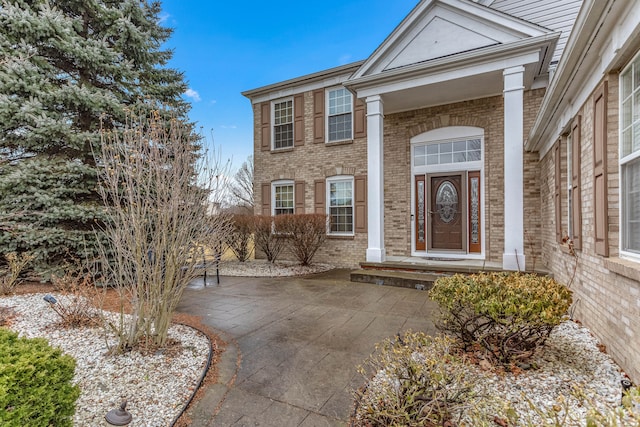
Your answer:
[361,320,640,427]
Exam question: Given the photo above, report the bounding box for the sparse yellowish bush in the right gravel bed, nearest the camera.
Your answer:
[350,332,479,427]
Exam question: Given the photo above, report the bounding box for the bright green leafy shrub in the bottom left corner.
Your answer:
[0,329,80,427]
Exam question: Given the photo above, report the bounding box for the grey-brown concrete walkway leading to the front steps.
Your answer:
[178,270,437,427]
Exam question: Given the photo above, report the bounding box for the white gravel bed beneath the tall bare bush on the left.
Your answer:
[0,294,209,427]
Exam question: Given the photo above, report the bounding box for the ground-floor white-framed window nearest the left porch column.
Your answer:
[327,177,353,235]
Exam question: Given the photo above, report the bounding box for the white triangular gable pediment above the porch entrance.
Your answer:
[353,0,550,78]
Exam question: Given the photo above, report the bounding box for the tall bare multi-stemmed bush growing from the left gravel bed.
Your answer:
[96,113,229,351]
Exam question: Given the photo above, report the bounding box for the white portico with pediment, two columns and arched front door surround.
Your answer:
[344,0,559,270]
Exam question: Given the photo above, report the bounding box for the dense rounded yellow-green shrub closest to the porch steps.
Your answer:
[429,273,571,364]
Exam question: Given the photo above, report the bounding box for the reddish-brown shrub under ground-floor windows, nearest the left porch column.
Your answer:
[278,214,327,265]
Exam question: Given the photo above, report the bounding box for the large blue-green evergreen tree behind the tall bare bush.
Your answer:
[0,0,189,272]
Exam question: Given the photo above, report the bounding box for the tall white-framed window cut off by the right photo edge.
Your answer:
[620,54,640,257]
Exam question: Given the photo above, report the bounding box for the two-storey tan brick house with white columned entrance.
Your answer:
[243,0,640,380]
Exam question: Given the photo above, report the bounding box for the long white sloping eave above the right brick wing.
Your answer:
[525,0,615,151]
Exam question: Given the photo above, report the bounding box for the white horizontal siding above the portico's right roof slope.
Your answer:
[489,0,582,64]
